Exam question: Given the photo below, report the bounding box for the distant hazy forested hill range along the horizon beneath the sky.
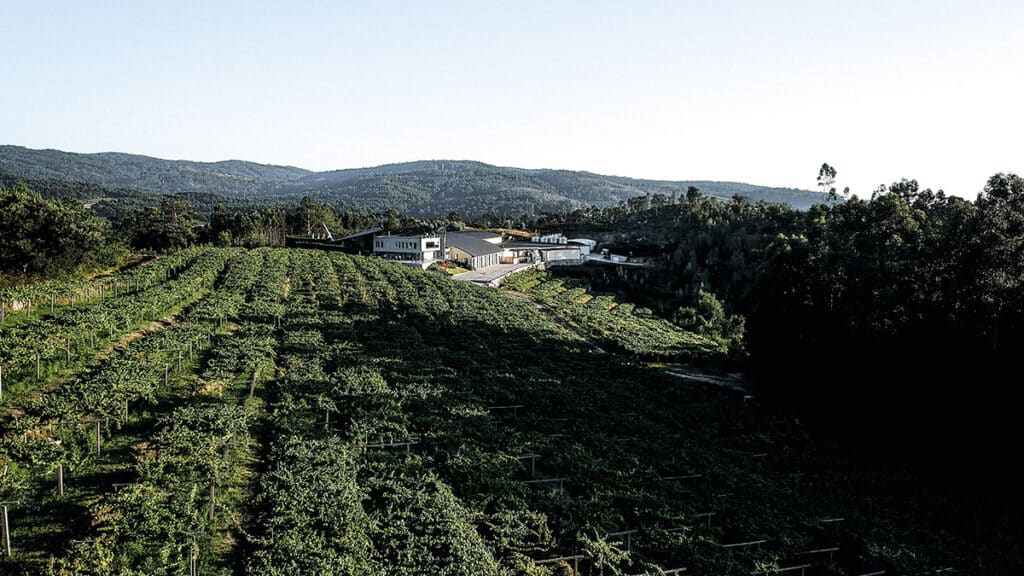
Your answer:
[0,146,823,217]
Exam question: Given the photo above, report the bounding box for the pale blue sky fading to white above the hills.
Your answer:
[0,0,1024,198]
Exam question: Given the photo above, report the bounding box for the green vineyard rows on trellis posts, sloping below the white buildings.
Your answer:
[0,248,1022,576]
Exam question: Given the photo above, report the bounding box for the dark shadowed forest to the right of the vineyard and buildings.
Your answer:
[539,174,1024,471]
